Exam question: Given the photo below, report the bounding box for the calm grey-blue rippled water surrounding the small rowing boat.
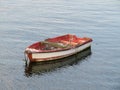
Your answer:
[0,0,120,90]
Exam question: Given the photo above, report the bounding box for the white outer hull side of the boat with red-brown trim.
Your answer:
[25,42,91,62]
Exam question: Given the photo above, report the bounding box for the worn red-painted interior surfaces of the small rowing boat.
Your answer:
[28,34,92,52]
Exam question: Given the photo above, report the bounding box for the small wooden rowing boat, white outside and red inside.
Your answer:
[25,34,92,62]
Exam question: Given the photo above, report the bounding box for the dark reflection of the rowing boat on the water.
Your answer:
[25,47,91,77]
